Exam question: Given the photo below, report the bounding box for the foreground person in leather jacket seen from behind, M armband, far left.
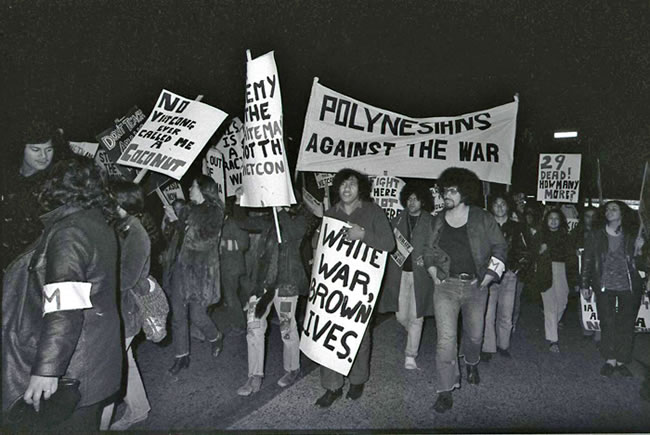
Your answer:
[2,159,123,432]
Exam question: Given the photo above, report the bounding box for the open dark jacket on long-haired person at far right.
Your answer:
[580,228,643,295]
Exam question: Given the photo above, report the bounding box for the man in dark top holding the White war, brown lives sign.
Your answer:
[314,169,395,408]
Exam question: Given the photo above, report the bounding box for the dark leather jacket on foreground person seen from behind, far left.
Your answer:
[2,206,123,407]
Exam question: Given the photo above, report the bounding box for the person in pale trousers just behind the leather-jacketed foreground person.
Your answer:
[101,181,151,430]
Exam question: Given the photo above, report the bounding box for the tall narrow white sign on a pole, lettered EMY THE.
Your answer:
[241,51,296,207]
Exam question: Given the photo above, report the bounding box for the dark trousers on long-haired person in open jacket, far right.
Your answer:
[596,291,641,363]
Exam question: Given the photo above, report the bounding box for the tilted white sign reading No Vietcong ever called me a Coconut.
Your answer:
[117,90,227,180]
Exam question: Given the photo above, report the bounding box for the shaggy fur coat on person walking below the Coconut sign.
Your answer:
[171,202,223,307]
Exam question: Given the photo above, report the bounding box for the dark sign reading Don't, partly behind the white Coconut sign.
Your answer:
[96,106,147,180]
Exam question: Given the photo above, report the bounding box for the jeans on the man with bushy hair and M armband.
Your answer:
[433,278,488,393]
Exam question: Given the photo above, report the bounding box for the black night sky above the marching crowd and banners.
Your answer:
[0,0,650,198]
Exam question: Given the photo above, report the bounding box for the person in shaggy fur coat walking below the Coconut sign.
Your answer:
[169,175,224,375]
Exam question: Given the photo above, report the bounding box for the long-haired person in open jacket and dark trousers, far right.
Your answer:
[581,201,643,377]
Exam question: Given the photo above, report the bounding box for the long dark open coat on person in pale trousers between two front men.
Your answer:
[378,211,433,317]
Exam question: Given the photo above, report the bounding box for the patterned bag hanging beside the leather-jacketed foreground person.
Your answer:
[131,276,169,343]
